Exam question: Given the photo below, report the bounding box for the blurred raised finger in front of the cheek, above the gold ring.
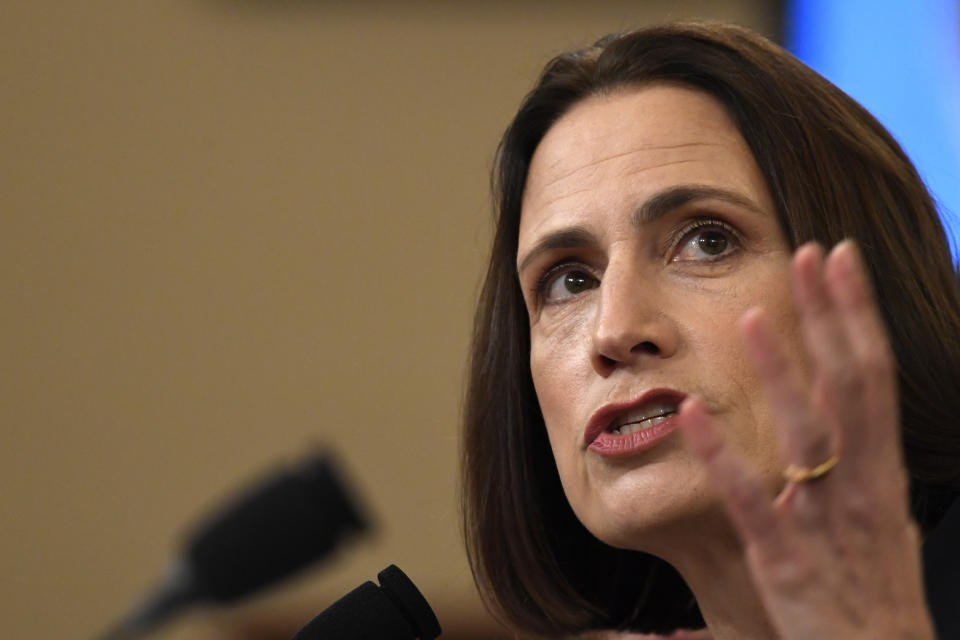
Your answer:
[740,309,836,476]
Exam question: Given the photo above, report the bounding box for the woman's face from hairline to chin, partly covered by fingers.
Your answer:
[517,85,802,552]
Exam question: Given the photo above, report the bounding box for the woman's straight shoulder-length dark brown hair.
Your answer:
[462,24,960,634]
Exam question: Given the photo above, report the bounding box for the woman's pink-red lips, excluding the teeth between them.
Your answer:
[583,388,687,458]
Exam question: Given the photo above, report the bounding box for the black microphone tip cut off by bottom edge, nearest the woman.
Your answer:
[292,565,440,640]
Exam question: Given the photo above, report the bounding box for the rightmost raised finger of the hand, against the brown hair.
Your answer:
[825,241,899,453]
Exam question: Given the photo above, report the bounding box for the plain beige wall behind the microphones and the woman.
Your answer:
[0,0,776,638]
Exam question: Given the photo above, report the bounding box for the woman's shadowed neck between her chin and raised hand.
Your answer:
[651,518,777,640]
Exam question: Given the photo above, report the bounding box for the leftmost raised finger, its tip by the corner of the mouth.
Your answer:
[678,397,784,557]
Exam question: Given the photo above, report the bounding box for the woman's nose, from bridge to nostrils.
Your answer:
[592,267,680,376]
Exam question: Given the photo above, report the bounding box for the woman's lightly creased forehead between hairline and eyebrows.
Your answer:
[521,85,772,243]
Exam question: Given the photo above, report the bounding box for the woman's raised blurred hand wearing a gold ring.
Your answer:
[681,242,934,640]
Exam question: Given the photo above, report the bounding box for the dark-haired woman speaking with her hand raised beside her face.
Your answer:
[463,25,960,639]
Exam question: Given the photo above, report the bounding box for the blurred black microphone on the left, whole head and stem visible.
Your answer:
[101,454,369,640]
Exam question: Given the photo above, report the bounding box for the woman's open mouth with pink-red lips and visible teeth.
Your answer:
[584,389,686,458]
